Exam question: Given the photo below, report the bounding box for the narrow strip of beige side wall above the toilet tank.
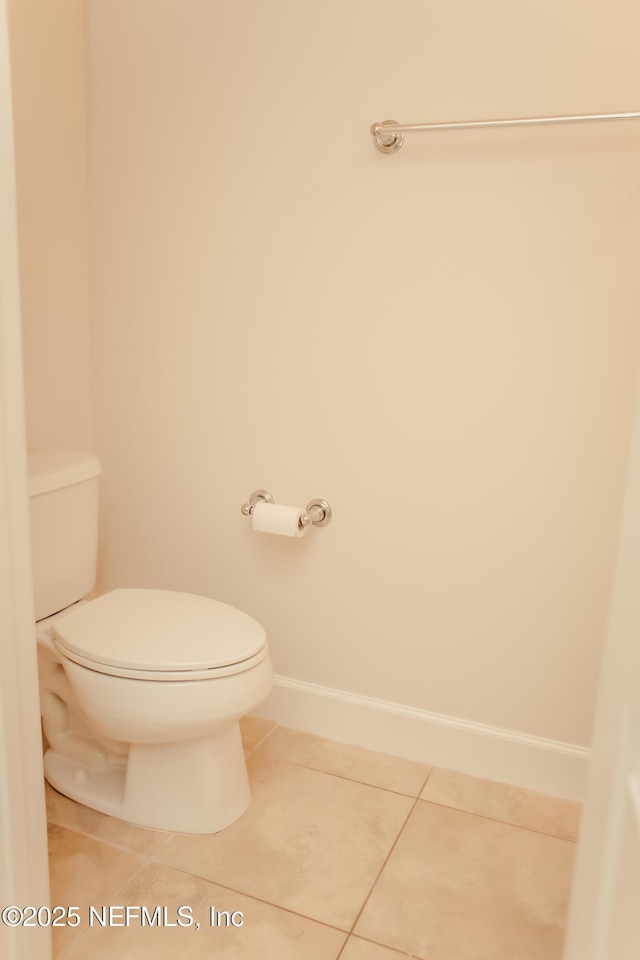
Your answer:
[8,0,91,449]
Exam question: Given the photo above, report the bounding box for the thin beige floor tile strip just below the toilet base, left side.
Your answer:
[45,783,171,856]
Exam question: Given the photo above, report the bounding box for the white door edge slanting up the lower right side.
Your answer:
[564,364,640,960]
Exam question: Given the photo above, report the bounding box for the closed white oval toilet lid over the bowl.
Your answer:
[53,590,266,672]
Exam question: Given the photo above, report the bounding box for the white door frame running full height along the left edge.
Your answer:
[0,0,51,960]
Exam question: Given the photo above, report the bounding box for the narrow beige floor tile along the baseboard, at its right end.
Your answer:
[420,768,581,840]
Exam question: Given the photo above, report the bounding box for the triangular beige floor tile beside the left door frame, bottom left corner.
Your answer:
[49,823,145,953]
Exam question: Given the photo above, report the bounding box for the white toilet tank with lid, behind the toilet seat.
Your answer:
[29,450,102,620]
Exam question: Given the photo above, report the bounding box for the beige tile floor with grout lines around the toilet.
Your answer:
[42,718,579,960]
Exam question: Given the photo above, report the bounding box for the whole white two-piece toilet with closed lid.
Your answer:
[29,451,273,833]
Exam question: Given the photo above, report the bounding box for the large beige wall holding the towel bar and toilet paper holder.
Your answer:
[88,0,640,744]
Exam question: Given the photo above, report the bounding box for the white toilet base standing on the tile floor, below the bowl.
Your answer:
[44,720,251,833]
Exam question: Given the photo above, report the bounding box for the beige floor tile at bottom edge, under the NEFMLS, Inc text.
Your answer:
[60,863,345,960]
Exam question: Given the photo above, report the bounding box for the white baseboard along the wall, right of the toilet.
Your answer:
[257,676,590,801]
